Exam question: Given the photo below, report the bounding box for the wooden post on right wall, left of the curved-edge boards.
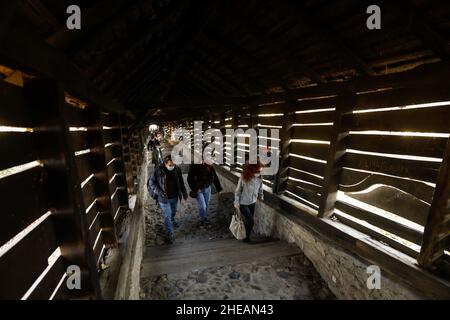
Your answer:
[319,91,356,218]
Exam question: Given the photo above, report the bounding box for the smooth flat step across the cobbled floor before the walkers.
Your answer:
[141,239,301,277]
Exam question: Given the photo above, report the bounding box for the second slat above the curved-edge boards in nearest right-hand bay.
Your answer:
[347,134,448,158]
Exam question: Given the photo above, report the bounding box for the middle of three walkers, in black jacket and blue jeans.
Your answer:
[187,161,222,227]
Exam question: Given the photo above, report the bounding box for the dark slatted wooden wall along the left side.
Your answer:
[0,78,135,299]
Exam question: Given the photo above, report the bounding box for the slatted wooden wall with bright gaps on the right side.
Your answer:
[207,82,450,276]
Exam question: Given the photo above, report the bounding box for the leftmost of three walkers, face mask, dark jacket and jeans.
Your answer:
[147,156,187,243]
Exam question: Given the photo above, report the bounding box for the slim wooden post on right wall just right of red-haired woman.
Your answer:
[272,102,295,194]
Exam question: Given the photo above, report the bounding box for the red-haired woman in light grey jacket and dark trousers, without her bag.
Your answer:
[234,160,264,242]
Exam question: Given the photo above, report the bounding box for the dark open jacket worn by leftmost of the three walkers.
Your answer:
[147,166,187,203]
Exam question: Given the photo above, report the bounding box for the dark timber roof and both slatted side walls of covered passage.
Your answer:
[0,0,450,299]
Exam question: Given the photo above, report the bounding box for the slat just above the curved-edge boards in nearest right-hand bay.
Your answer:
[344,152,439,183]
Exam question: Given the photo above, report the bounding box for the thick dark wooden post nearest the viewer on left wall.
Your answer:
[24,80,101,299]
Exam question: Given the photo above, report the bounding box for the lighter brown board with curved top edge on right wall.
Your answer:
[348,186,430,226]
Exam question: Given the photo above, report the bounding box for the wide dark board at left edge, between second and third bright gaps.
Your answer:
[0,167,50,245]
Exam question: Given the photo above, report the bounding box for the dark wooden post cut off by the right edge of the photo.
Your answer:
[418,140,450,269]
